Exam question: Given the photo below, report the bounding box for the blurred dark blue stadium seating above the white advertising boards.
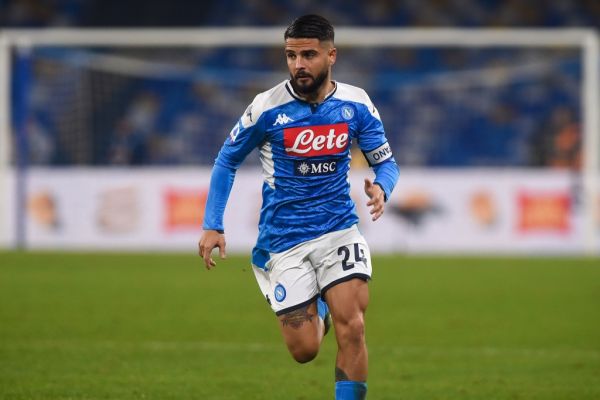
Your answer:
[2,0,600,168]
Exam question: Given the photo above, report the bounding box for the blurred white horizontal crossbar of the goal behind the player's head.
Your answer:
[0,27,596,47]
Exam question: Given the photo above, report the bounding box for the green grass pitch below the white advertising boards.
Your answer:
[0,252,600,400]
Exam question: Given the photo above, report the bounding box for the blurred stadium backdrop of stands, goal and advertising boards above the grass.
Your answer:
[0,0,600,254]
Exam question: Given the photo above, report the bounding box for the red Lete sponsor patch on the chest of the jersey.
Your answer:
[283,124,348,157]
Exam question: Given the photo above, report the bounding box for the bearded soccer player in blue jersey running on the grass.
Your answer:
[198,15,399,400]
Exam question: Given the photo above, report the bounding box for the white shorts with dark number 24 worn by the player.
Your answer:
[252,225,372,315]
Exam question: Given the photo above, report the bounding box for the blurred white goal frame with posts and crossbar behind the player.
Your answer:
[0,27,600,255]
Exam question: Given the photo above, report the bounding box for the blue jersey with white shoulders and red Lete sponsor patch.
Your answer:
[204,81,398,267]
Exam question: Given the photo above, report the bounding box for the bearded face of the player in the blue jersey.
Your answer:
[285,38,336,95]
